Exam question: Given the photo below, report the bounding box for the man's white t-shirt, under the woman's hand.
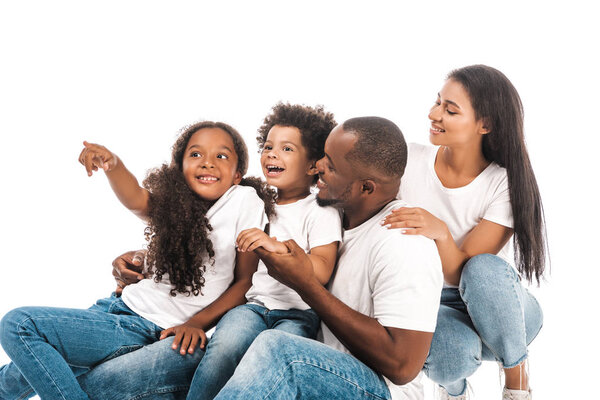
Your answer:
[319,200,443,400]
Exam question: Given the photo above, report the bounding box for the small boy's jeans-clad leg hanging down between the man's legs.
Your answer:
[187,304,268,400]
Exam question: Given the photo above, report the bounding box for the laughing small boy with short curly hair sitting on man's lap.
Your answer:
[187,103,341,400]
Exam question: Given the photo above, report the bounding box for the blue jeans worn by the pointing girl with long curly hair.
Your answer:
[0,294,162,400]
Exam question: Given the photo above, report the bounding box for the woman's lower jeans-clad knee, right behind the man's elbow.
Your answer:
[423,289,482,396]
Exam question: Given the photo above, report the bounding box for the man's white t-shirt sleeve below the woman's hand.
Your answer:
[369,232,443,332]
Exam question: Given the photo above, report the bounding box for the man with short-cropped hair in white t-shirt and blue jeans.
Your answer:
[80,117,443,399]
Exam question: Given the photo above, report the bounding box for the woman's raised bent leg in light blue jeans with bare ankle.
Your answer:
[460,254,543,389]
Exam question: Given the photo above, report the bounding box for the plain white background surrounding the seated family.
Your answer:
[0,0,600,399]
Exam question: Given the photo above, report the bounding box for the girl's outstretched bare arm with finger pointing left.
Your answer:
[79,141,150,219]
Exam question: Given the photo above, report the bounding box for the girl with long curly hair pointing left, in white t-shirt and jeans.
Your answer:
[0,121,272,399]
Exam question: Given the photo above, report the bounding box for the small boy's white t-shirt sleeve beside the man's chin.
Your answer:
[306,205,342,249]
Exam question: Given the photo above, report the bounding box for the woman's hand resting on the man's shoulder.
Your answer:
[381,207,450,240]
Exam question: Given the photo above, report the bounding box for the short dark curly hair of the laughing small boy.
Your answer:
[256,102,337,182]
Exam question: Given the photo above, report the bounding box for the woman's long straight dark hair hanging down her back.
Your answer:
[448,65,548,284]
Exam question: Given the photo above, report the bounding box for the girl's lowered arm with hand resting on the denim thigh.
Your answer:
[160,251,258,355]
